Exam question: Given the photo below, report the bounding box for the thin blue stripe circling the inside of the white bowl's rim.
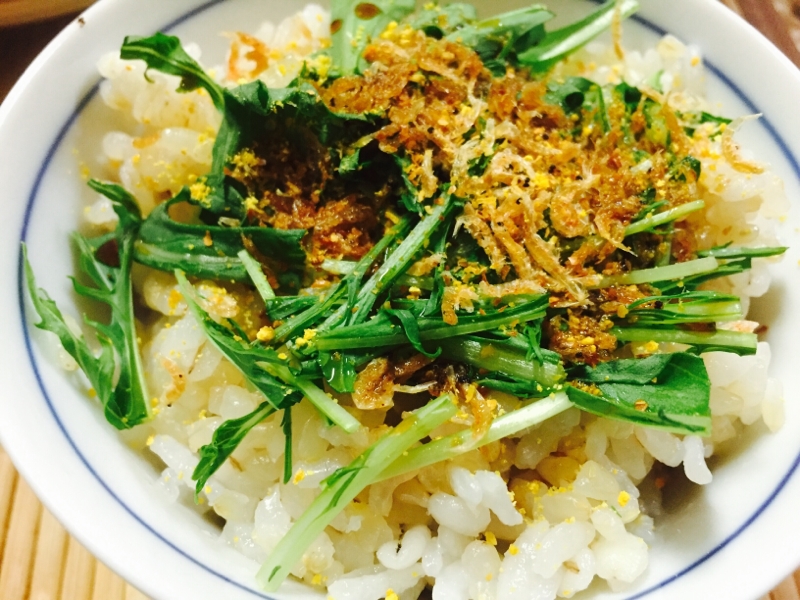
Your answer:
[17,0,800,600]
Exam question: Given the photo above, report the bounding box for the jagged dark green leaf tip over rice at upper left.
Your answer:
[120,33,225,111]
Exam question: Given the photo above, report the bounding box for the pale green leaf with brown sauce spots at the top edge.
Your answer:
[330,0,414,75]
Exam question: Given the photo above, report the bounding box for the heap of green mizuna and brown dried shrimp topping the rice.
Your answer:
[23,0,786,590]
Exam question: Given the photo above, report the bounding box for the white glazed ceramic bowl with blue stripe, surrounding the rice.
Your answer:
[0,0,800,600]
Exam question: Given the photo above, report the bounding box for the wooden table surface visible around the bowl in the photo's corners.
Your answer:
[0,0,800,600]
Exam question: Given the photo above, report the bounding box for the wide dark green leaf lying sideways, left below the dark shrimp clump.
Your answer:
[134,189,306,281]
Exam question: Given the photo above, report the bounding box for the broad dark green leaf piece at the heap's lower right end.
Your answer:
[567,352,711,435]
